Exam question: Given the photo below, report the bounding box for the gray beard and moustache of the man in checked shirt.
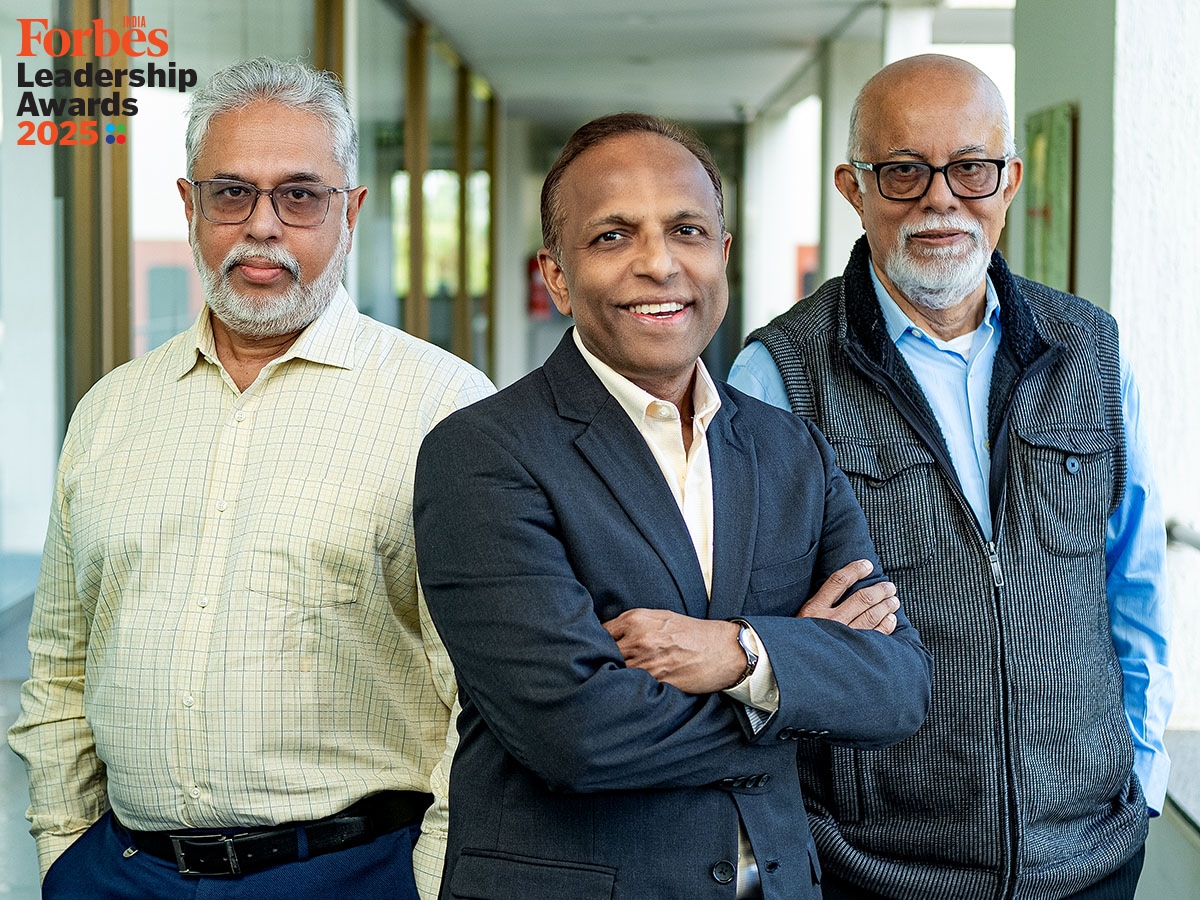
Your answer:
[190,217,350,340]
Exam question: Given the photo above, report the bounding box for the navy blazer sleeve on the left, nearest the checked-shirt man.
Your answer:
[414,416,749,791]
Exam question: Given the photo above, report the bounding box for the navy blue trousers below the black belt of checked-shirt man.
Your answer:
[42,812,421,900]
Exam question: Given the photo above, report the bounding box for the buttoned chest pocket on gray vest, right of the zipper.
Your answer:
[1008,427,1117,557]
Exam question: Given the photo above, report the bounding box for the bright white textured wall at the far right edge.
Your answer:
[1111,0,1200,728]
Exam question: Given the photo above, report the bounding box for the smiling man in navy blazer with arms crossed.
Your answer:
[414,113,929,900]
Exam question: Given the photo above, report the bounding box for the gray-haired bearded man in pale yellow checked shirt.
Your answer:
[10,59,492,900]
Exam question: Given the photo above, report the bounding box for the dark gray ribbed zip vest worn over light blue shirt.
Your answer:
[748,239,1147,900]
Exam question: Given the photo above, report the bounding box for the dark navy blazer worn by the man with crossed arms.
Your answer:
[414,332,930,900]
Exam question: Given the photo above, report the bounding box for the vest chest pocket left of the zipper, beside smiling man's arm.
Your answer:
[830,440,937,572]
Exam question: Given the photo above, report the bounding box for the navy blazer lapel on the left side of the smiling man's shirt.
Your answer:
[542,331,708,618]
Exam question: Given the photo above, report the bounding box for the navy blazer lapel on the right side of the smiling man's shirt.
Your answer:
[708,386,758,619]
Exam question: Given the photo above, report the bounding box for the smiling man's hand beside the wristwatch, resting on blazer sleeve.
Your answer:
[604,610,746,694]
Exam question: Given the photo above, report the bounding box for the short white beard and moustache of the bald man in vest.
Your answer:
[883,216,991,310]
